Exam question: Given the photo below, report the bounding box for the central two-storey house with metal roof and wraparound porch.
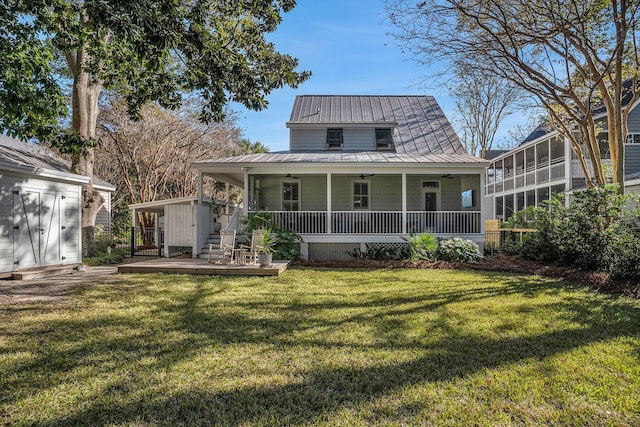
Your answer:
[193,96,487,259]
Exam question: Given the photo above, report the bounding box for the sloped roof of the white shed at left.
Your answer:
[0,134,115,191]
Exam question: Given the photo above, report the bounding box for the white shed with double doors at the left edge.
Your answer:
[0,135,115,276]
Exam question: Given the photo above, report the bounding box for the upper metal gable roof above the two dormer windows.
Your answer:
[287,95,466,155]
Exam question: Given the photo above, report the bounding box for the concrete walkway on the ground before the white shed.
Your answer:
[0,265,118,304]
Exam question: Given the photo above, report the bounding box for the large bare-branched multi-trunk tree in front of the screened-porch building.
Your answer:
[387,0,639,191]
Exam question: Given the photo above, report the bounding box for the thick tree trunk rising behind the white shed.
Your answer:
[67,43,104,256]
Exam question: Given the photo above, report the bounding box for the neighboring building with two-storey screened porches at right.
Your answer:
[484,104,640,221]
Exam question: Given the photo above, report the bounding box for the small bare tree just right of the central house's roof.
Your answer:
[450,65,518,159]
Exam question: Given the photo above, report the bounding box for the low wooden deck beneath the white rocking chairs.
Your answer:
[118,258,289,276]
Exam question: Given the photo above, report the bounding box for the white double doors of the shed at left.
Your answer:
[13,189,61,268]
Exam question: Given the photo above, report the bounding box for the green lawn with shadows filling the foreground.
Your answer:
[0,268,640,426]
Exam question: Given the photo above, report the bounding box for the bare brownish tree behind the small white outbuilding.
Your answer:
[95,100,241,242]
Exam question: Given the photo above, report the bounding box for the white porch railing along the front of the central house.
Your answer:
[264,211,481,234]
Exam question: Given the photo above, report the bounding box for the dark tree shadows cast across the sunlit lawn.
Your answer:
[0,274,640,425]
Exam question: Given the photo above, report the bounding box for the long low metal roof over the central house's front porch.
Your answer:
[194,151,488,167]
